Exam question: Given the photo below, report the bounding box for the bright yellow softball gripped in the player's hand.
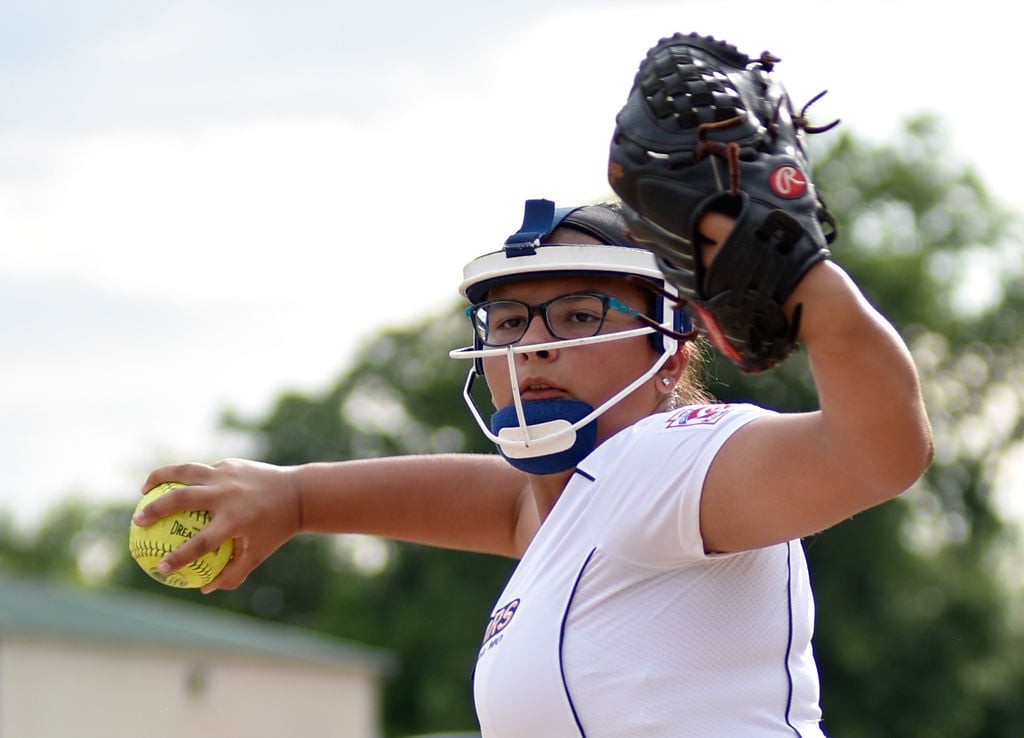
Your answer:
[128,482,234,589]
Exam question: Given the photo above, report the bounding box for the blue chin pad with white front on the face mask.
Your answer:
[490,399,597,474]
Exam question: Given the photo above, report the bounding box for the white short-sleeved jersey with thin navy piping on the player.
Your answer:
[473,405,823,738]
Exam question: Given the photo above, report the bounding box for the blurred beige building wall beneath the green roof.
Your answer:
[0,635,380,738]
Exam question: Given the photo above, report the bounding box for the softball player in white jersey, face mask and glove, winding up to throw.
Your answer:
[136,31,932,738]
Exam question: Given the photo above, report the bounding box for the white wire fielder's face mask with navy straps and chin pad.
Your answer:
[450,200,693,474]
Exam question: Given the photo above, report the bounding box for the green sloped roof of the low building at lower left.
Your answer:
[0,576,394,676]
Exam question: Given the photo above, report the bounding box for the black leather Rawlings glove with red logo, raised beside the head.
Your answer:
[608,34,838,373]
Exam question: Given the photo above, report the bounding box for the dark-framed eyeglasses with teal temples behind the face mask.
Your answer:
[466,292,646,347]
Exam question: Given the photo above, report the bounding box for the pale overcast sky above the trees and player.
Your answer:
[0,0,1024,523]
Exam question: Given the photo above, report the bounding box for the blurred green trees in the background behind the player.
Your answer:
[6,119,1024,738]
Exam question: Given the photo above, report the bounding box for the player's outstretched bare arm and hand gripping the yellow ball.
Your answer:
[134,454,536,593]
